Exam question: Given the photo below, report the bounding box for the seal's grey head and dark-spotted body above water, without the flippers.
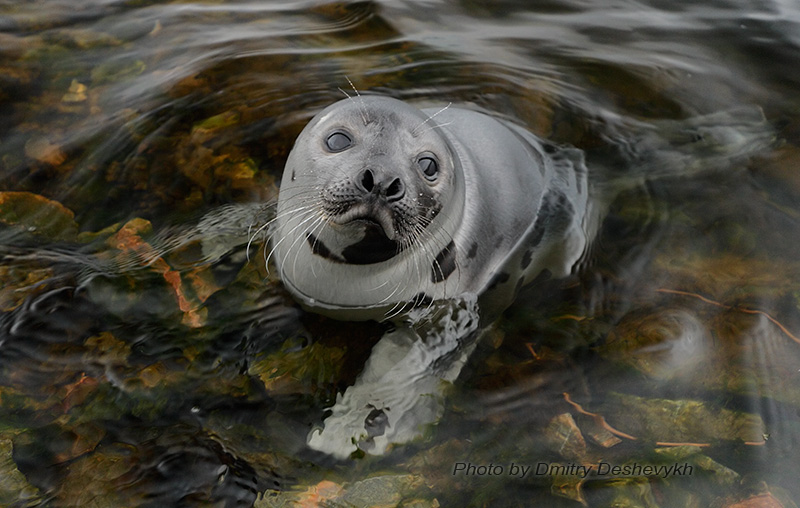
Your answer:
[270,96,590,320]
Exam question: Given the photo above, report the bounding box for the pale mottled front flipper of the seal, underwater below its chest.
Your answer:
[308,295,480,459]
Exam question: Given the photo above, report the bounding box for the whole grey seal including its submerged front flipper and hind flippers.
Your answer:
[253,95,764,458]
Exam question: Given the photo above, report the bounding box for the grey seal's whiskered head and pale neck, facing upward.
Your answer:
[273,96,464,317]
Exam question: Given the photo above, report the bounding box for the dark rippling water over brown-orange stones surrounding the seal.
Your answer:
[0,0,800,507]
